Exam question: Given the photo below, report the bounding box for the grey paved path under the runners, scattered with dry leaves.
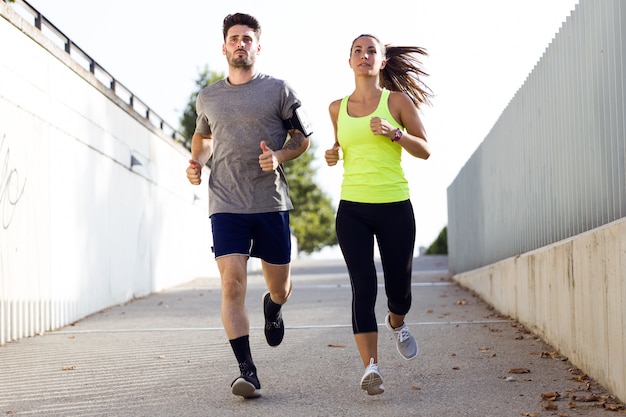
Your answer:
[0,256,618,417]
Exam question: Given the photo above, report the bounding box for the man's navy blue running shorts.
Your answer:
[211,211,291,265]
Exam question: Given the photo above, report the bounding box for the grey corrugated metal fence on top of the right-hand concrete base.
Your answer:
[448,0,626,273]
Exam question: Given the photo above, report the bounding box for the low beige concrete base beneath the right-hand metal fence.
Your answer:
[454,219,626,401]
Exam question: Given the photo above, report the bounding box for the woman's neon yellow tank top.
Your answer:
[337,90,409,203]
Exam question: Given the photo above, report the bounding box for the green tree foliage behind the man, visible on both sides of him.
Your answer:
[180,67,337,254]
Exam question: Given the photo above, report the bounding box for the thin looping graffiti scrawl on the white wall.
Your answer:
[0,134,26,229]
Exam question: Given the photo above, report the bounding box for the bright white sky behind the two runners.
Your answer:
[20,0,578,255]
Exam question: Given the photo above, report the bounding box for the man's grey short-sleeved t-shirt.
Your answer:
[196,74,300,216]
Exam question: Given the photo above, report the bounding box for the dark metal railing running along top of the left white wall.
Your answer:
[2,0,186,143]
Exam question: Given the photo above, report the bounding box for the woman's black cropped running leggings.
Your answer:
[335,200,415,334]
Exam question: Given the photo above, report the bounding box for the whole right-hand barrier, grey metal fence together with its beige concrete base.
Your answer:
[448,0,626,400]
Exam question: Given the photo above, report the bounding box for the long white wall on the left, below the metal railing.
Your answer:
[0,2,217,344]
